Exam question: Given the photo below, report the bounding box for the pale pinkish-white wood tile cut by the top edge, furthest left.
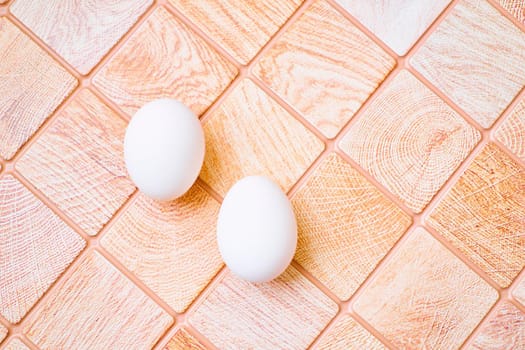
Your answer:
[10,0,153,74]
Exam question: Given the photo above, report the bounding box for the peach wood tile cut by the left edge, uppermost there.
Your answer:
[0,18,77,159]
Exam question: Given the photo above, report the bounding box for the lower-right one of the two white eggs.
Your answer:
[217,176,297,282]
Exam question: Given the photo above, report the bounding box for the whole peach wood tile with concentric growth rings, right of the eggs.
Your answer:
[340,70,480,213]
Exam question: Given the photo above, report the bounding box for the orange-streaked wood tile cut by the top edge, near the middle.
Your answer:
[169,0,302,64]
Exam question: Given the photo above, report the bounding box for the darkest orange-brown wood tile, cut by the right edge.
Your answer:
[429,144,525,287]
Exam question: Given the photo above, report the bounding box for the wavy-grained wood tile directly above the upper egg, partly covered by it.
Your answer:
[93,7,237,115]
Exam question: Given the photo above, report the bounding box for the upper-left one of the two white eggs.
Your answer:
[124,99,204,200]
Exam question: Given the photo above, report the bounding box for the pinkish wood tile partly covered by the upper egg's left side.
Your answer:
[17,90,135,235]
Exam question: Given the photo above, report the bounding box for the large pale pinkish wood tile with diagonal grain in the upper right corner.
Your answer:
[411,0,525,128]
